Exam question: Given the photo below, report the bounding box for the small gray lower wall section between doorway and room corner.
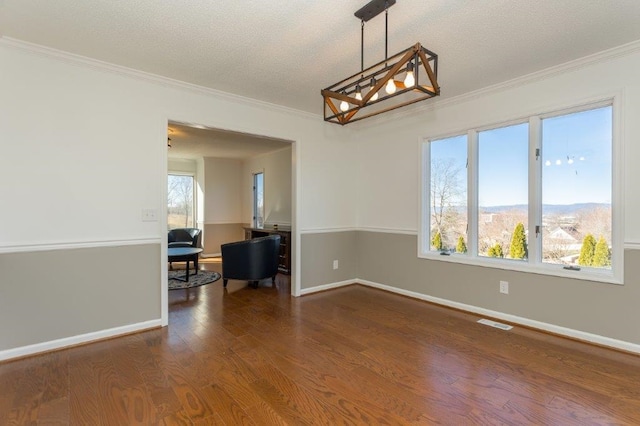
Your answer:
[300,231,358,290]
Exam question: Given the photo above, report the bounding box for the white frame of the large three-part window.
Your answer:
[418,93,624,284]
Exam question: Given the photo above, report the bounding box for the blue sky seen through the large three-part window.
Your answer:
[431,107,612,207]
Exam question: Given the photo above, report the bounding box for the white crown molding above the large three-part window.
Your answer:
[353,40,640,128]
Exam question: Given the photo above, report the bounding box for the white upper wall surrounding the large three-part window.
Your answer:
[357,44,640,244]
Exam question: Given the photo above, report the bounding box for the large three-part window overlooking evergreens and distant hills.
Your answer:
[420,101,622,282]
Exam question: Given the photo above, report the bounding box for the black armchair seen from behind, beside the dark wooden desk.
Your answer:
[221,235,280,288]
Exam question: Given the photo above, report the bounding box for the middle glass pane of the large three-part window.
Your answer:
[478,123,529,260]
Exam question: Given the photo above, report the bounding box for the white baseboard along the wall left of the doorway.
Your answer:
[0,319,161,361]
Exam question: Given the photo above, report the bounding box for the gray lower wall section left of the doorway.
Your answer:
[0,243,161,351]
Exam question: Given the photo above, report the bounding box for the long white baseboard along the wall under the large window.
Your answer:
[356,279,640,354]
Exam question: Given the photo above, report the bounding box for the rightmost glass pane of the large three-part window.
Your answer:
[542,106,613,269]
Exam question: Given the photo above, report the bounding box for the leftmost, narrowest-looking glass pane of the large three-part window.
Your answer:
[429,136,467,253]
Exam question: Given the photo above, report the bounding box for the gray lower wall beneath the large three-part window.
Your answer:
[356,231,640,344]
